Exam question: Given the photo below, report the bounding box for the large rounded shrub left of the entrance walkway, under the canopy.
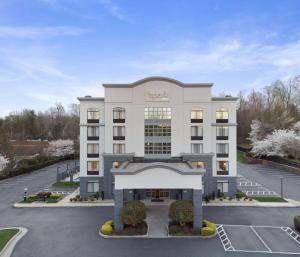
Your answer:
[121,201,146,226]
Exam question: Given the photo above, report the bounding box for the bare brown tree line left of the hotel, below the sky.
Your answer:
[0,103,79,155]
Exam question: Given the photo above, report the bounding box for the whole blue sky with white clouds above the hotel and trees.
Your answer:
[0,0,300,116]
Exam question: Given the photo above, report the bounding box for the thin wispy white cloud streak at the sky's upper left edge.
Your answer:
[0,26,88,39]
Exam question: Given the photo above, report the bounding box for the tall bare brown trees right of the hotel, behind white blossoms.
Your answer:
[237,76,300,145]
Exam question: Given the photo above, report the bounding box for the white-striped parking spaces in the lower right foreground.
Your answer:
[217,224,300,255]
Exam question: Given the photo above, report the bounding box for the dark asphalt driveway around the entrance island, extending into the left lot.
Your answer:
[0,159,300,257]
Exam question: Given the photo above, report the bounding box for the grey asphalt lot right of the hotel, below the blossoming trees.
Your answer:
[238,163,300,201]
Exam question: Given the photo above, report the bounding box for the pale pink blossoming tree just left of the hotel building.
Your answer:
[46,139,74,157]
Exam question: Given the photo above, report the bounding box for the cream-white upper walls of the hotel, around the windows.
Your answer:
[79,77,237,196]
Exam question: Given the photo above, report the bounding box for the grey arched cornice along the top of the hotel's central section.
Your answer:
[103,76,213,88]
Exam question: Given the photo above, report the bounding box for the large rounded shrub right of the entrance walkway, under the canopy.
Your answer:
[169,200,194,226]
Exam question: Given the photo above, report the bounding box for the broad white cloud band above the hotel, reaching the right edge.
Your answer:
[130,39,300,74]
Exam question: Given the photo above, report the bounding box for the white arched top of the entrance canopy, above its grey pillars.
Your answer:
[111,162,205,189]
